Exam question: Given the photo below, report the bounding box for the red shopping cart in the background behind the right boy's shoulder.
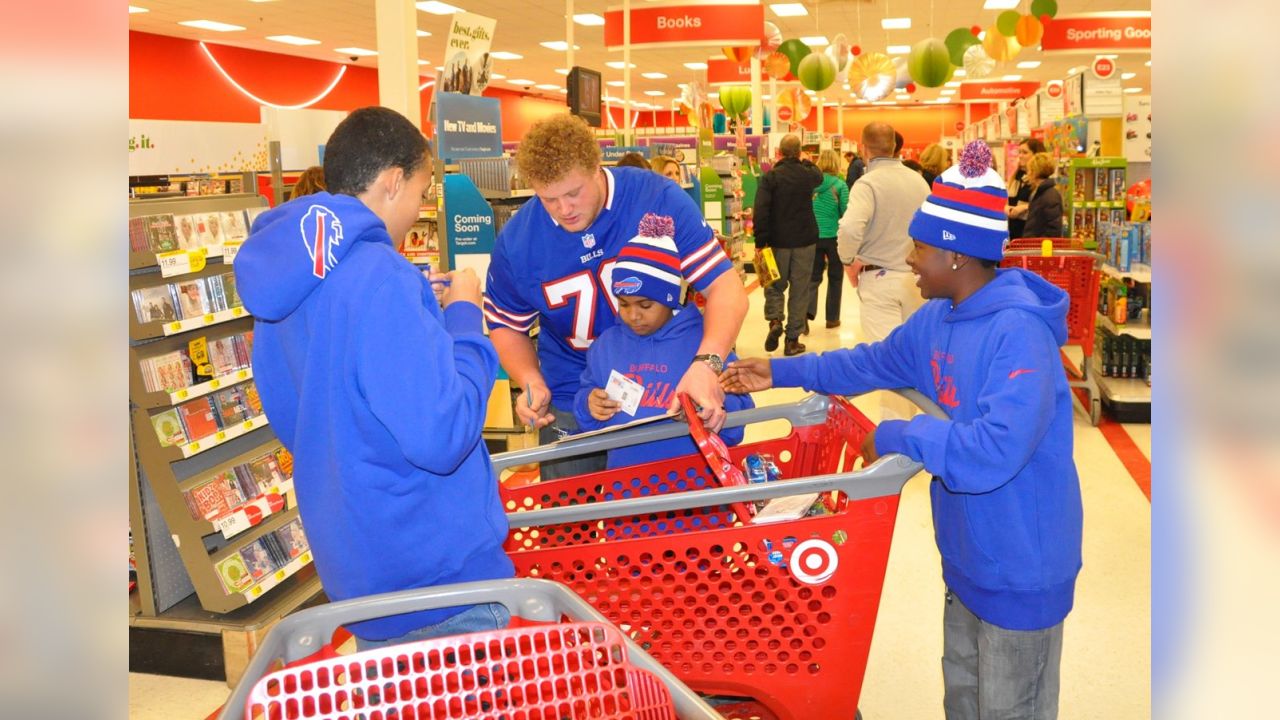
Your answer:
[1000,248,1102,425]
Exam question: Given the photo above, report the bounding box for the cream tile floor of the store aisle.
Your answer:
[129,271,1151,720]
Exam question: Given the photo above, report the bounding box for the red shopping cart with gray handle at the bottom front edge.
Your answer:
[220,579,721,720]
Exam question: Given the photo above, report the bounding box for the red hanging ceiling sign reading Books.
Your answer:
[604,3,764,50]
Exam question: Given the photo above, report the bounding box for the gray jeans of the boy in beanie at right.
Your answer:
[942,591,1062,720]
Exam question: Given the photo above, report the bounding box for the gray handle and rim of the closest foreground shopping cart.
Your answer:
[219,579,722,720]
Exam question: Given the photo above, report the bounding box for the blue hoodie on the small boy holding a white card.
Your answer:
[573,307,755,468]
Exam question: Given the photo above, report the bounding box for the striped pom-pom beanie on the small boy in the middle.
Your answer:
[613,213,684,309]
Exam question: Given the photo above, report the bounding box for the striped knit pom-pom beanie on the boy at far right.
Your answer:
[908,140,1009,260]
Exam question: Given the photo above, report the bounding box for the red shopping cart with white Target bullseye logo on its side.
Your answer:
[494,392,941,720]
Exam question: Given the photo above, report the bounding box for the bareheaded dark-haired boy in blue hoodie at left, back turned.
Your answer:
[236,108,513,650]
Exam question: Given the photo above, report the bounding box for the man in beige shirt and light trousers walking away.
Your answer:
[836,122,929,418]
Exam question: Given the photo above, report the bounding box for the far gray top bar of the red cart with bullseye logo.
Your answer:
[492,388,947,473]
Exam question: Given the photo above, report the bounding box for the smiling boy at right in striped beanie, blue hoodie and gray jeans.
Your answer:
[722,142,1083,720]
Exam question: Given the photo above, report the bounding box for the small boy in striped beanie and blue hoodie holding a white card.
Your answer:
[573,213,755,468]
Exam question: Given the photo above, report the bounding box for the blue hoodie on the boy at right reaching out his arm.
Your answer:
[772,269,1083,630]
